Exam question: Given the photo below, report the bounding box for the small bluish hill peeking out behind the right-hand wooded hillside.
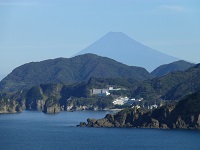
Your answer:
[151,60,195,77]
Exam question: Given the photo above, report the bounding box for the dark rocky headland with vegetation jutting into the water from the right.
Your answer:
[80,91,200,129]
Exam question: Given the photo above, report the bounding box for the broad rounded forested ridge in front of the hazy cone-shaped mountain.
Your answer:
[0,54,152,91]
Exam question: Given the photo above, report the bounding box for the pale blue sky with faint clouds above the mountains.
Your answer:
[0,0,200,75]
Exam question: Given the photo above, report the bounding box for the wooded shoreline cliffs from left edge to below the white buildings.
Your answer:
[0,80,113,113]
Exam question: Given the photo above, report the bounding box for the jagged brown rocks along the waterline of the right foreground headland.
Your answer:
[79,111,200,129]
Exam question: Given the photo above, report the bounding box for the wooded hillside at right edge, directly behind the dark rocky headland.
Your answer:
[132,64,200,100]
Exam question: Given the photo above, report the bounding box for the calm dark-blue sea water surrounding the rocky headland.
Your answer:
[0,111,200,150]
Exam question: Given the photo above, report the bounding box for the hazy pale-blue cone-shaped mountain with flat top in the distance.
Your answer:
[77,32,178,71]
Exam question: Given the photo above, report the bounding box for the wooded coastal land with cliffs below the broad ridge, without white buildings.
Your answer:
[1,64,200,113]
